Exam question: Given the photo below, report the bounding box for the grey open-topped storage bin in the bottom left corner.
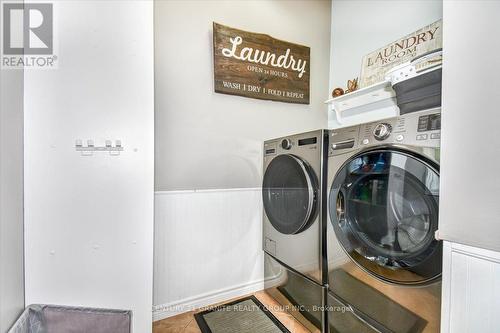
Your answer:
[8,305,132,333]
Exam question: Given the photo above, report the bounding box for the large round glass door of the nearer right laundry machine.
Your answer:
[329,150,442,284]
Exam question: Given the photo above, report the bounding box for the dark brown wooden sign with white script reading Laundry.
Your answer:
[213,22,310,104]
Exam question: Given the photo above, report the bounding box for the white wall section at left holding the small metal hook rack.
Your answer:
[24,1,154,333]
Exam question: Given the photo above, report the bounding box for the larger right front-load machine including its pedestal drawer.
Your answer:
[327,109,442,333]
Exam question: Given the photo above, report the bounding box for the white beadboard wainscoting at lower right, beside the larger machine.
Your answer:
[441,242,500,333]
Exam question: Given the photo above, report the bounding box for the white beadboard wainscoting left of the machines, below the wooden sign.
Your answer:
[153,188,264,321]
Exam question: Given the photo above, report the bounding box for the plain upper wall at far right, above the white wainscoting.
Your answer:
[439,1,500,251]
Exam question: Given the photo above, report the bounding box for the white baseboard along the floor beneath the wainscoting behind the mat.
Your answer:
[153,279,264,321]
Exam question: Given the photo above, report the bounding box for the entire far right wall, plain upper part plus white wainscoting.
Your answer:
[439,1,500,333]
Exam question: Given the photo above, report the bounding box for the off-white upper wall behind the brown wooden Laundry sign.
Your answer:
[155,1,330,190]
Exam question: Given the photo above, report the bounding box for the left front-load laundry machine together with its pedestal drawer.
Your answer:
[262,130,328,330]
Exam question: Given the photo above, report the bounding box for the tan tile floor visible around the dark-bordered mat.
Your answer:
[153,291,310,333]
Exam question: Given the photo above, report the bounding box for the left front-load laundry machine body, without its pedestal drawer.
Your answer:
[262,130,327,284]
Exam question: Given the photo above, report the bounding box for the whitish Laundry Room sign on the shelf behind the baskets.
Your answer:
[360,20,443,88]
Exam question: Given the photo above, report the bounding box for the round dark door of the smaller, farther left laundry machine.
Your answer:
[262,155,317,234]
